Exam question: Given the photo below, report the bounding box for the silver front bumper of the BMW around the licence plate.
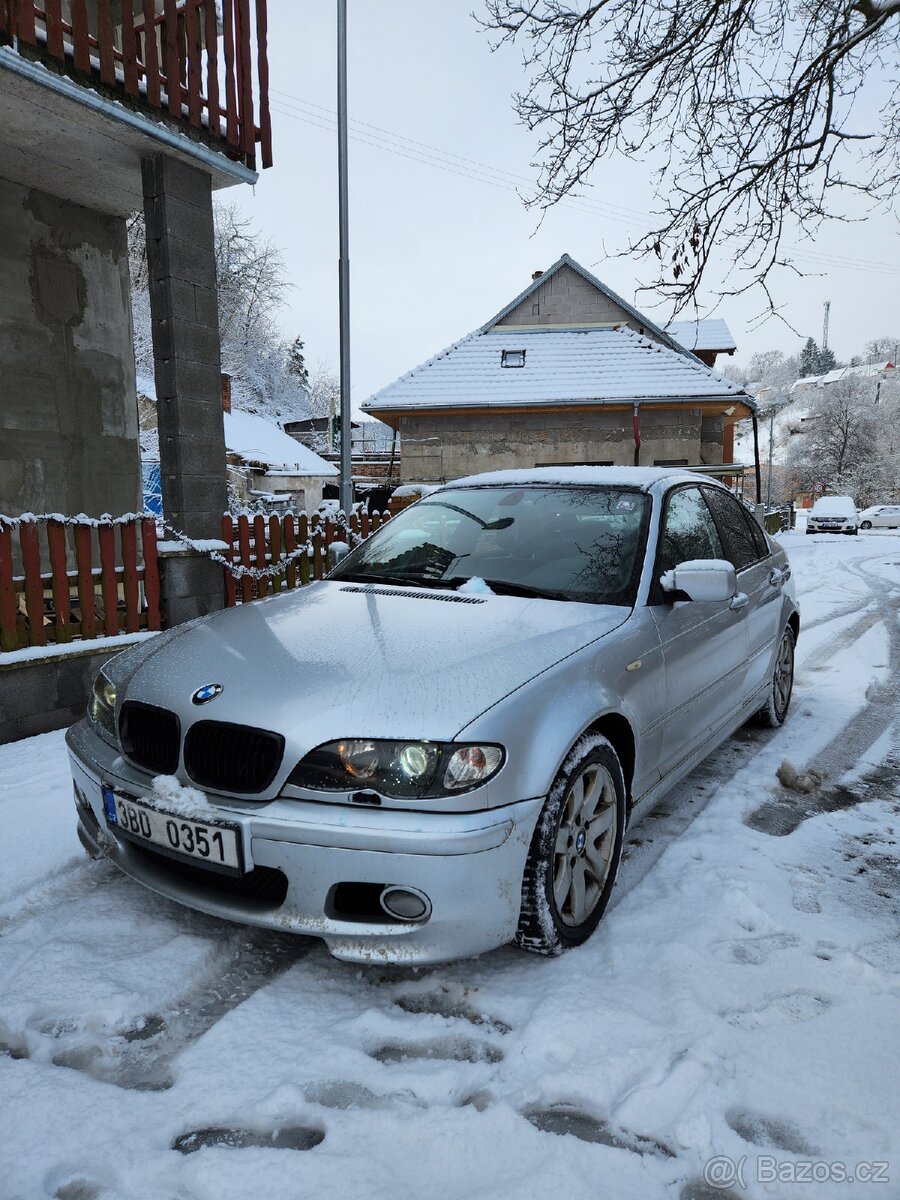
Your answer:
[66,721,542,964]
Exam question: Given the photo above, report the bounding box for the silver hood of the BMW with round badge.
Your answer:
[119,581,630,754]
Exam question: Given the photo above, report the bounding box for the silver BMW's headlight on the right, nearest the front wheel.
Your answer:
[288,738,504,800]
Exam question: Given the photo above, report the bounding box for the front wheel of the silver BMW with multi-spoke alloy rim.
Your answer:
[515,733,625,956]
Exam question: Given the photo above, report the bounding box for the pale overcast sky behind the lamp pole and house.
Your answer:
[227,0,900,408]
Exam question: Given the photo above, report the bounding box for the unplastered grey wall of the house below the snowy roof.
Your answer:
[401,409,705,484]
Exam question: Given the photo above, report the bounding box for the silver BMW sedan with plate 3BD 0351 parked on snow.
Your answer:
[67,467,799,964]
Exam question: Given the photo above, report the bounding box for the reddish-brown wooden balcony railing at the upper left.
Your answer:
[0,0,272,167]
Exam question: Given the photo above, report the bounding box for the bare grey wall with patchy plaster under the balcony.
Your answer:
[0,176,140,516]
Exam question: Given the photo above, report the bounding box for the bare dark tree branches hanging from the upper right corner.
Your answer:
[481,0,900,311]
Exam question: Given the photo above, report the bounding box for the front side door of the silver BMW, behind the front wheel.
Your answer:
[649,485,746,776]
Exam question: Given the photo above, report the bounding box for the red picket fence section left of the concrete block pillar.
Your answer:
[0,517,161,652]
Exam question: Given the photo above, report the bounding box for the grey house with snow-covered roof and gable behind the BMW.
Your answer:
[362,254,755,482]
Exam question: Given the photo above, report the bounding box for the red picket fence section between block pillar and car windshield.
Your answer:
[222,512,388,608]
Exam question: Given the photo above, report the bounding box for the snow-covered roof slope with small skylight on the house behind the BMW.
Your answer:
[362,326,752,413]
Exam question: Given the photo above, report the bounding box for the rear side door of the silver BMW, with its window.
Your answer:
[703,487,790,698]
